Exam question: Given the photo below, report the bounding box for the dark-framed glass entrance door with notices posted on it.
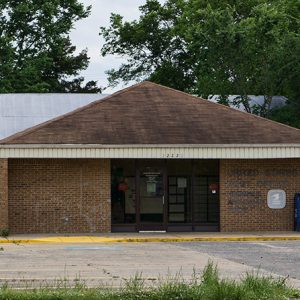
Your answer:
[139,167,165,230]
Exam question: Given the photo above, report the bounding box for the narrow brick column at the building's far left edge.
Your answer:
[0,159,8,230]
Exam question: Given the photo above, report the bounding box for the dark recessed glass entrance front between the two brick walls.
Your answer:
[111,159,220,232]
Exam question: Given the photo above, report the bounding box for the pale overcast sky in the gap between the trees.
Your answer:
[71,0,152,94]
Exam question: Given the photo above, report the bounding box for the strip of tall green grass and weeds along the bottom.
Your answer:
[0,263,300,300]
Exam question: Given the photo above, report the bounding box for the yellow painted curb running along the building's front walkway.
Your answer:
[0,236,300,244]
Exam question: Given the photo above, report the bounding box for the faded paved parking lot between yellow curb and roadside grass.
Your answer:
[0,241,300,288]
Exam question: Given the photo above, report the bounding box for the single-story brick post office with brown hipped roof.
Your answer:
[0,82,300,233]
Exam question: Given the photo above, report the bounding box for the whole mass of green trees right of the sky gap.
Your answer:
[100,0,300,122]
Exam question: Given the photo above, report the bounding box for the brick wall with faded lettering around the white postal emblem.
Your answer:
[220,159,300,232]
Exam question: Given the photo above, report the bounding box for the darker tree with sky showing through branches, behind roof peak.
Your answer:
[100,0,193,90]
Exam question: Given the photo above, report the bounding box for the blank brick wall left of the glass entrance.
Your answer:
[8,159,111,233]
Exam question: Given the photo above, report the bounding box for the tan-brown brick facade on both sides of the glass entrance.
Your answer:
[0,159,300,233]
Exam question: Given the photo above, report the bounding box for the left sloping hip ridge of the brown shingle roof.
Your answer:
[0,82,144,144]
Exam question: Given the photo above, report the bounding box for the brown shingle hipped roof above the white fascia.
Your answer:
[1,81,300,145]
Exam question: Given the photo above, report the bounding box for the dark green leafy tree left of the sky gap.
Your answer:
[0,0,99,93]
